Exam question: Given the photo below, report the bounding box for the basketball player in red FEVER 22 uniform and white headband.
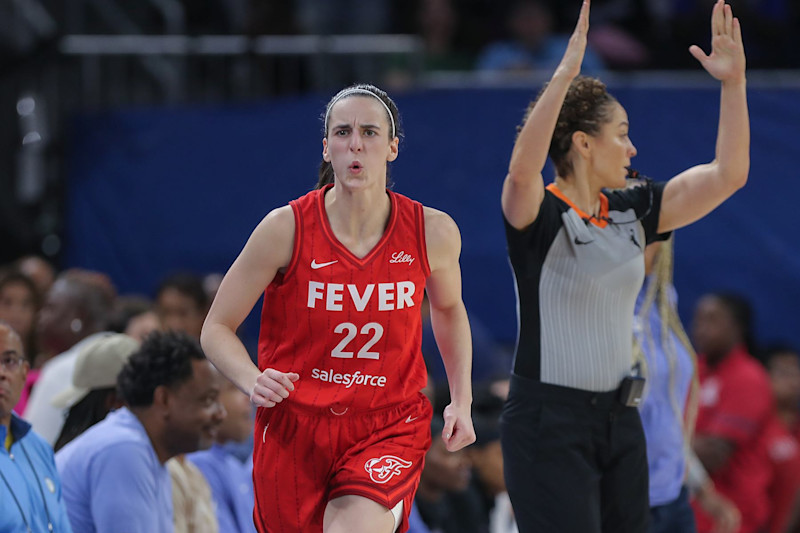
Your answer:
[201,85,475,533]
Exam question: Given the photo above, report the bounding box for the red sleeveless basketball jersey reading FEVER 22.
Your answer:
[258,185,430,412]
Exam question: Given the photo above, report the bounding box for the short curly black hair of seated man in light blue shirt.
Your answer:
[117,331,206,407]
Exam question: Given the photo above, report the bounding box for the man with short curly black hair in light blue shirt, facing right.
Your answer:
[56,332,225,533]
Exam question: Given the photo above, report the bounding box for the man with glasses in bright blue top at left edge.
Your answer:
[0,321,72,533]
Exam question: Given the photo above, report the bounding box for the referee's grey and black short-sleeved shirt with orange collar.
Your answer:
[506,181,666,392]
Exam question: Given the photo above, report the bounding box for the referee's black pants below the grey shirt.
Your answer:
[500,375,650,533]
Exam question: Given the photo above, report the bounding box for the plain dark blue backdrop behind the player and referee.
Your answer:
[65,84,800,374]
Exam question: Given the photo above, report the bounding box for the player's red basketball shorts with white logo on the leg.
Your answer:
[253,394,433,533]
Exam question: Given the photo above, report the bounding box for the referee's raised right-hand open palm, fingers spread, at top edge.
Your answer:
[689,0,746,82]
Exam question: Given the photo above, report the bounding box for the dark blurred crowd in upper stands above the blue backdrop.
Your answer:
[184,0,800,72]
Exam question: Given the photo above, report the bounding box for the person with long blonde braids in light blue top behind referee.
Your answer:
[633,238,740,533]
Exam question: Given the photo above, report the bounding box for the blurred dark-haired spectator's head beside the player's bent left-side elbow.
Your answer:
[156,273,208,339]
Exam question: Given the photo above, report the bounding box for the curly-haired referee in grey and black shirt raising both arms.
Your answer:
[501,0,750,533]
